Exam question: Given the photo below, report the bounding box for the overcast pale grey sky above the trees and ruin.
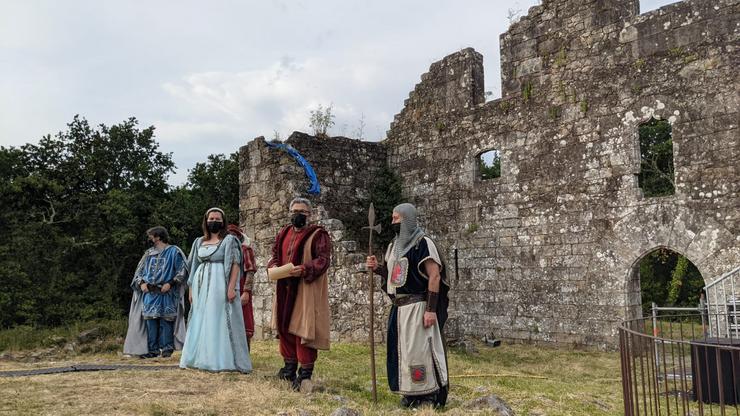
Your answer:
[0,0,673,184]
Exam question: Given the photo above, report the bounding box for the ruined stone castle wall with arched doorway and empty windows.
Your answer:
[240,0,740,348]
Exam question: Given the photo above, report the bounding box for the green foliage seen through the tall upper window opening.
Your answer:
[638,118,675,197]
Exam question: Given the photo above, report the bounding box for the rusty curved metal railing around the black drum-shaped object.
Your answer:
[619,308,740,416]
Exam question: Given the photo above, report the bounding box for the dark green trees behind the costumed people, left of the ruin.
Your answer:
[0,117,238,328]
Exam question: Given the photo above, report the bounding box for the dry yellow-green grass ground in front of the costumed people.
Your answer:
[0,328,623,415]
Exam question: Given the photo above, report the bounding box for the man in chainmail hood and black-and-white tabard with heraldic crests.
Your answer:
[367,203,449,407]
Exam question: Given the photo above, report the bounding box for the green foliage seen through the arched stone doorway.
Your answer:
[639,248,704,314]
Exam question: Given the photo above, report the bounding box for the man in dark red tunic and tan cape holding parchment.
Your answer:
[267,198,331,390]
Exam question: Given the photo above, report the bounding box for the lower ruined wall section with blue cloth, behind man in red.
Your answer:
[239,133,386,340]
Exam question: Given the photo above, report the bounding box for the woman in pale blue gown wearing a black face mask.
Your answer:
[180,208,252,373]
